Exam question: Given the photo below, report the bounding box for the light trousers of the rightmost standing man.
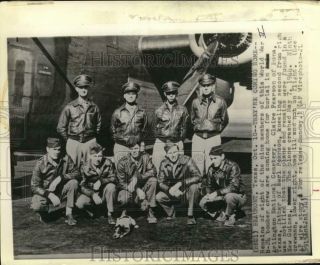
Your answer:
[192,134,221,174]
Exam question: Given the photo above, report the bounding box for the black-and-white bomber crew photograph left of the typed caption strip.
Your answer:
[7,32,252,258]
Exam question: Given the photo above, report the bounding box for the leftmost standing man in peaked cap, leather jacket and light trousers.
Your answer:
[57,74,101,167]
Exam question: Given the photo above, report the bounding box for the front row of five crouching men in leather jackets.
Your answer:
[31,138,246,225]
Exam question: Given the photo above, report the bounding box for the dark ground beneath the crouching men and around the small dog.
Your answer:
[13,174,252,256]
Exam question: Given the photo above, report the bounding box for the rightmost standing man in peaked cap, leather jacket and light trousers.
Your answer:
[191,74,229,173]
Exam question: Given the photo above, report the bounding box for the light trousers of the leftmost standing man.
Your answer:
[66,138,97,167]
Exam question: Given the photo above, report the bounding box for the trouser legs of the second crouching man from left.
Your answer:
[76,183,117,213]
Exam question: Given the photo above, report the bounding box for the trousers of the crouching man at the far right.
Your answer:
[199,192,247,216]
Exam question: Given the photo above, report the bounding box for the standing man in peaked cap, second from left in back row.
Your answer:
[111,82,148,168]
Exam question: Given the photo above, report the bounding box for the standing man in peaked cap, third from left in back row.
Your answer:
[152,81,189,172]
